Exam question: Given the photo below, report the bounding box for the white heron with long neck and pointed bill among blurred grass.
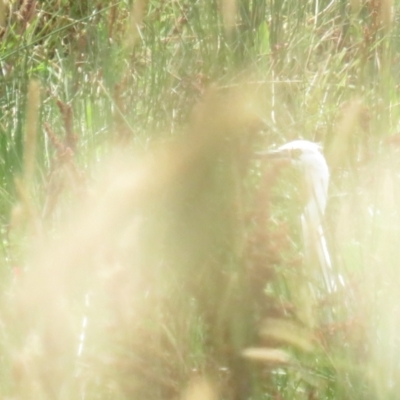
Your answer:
[259,140,342,293]
